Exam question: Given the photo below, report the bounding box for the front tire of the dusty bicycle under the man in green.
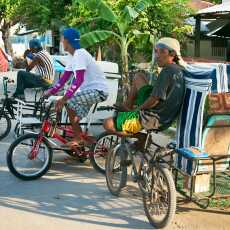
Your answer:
[105,145,127,196]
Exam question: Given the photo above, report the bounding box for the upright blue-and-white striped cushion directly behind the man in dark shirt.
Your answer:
[176,78,211,148]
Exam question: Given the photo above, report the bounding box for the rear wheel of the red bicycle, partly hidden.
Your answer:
[89,132,121,174]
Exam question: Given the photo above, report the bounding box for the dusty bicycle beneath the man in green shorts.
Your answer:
[105,130,176,228]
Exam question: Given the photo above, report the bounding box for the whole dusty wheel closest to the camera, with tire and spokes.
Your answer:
[143,165,176,228]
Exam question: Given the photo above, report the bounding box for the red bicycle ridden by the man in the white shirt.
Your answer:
[7,99,119,180]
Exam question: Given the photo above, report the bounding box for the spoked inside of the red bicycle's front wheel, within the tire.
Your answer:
[12,138,49,176]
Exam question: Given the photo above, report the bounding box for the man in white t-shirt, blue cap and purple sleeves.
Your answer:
[45,28,108,148]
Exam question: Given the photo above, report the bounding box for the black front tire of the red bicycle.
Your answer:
[7,133,53,180]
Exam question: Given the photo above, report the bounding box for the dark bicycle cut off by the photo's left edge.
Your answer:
[0,77,42,140]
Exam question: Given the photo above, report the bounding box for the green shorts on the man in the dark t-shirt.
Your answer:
[114,85,153,131]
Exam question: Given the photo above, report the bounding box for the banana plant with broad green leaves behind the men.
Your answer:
[75,0,155,91]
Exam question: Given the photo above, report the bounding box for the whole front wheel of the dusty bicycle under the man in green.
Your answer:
[105,144,127,196]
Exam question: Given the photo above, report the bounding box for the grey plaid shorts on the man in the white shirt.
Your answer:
[67,89,108,119]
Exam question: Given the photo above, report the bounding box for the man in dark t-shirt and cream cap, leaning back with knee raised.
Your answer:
[104,38,185,141]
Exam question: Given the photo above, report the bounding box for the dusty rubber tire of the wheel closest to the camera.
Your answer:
[143,165,176,229]
